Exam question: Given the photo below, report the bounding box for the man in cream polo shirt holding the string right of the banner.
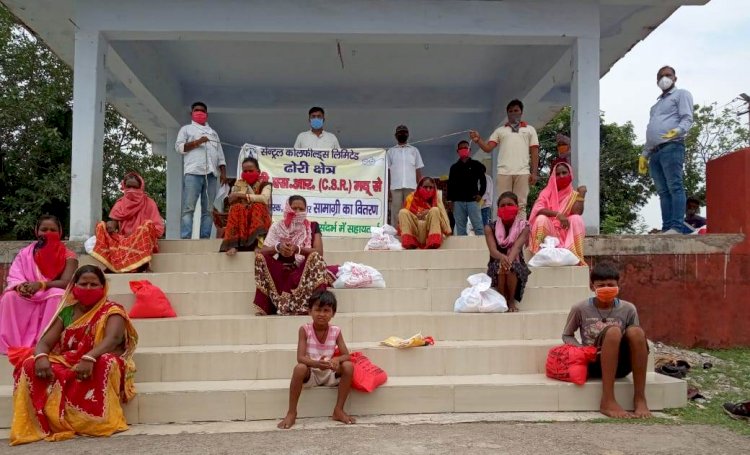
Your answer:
[469,100,539,216]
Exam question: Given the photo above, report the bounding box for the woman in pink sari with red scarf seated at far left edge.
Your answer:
[0,215,78,354]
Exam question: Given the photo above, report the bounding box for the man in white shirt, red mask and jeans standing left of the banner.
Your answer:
[174,101,227,239]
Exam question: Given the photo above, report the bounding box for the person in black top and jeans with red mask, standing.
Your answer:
[448,141,487,235]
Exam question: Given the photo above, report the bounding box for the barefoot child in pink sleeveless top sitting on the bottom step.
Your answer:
[278,291,355,430]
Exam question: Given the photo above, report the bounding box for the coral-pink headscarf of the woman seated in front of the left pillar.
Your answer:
[109,172,164,237]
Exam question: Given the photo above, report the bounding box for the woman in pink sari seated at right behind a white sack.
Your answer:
[529,162,586,265]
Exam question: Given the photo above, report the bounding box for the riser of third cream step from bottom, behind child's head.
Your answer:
[134,311,568,347]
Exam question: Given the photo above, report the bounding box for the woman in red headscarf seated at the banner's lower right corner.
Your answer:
[398,177,451,250]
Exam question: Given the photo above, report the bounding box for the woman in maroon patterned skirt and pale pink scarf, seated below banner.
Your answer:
[255,195,338,316]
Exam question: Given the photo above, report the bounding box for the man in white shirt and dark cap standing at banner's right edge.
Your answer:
[386,125,424,227]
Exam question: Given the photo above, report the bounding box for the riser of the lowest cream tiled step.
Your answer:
[0,373,687,428]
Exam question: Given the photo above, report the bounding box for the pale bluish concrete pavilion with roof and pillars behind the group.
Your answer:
[1,0,708,239]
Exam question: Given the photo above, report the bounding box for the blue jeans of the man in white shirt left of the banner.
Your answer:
[180,174,216,239]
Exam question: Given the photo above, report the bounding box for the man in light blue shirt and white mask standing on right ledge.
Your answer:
[643,66,693,234]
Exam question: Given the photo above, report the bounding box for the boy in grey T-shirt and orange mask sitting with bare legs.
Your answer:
[563,262,651,419]
